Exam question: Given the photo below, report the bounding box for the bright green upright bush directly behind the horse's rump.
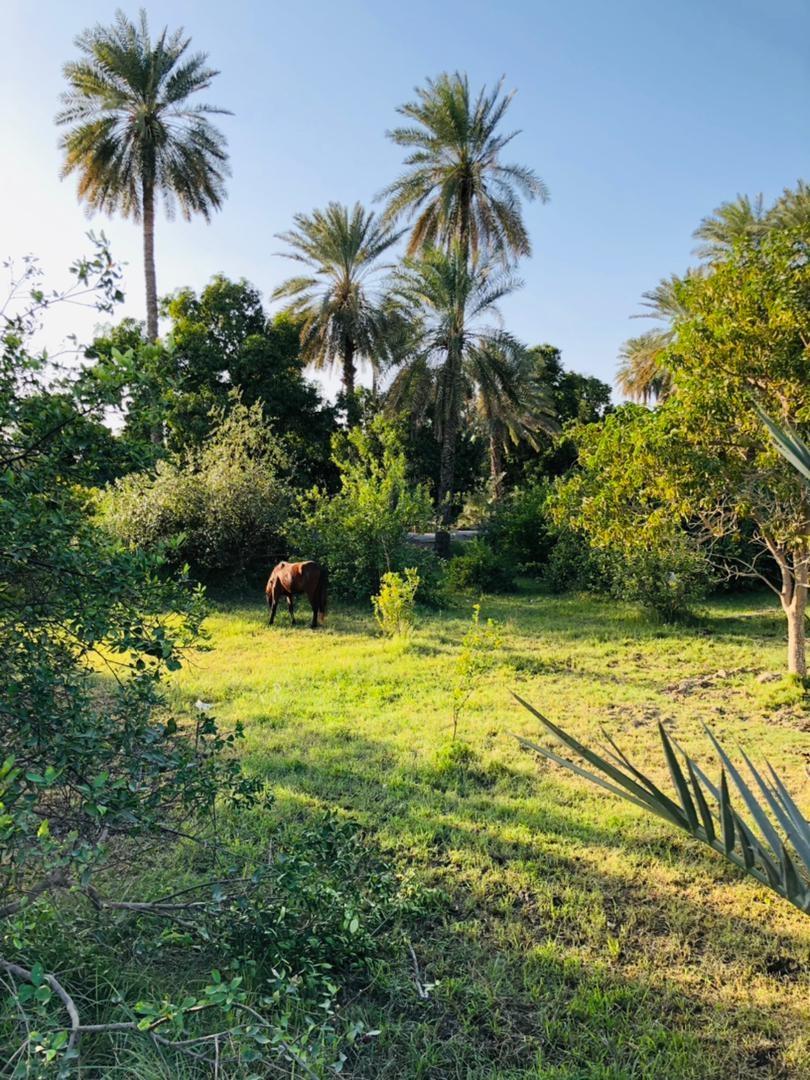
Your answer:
[289,417,432,600]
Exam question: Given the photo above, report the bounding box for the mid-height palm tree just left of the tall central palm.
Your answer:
[273,202,402,421]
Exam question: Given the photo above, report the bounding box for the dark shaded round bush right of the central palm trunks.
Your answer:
[484,484,555,572]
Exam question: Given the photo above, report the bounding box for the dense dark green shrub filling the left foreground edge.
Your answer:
[0,245,289,1076]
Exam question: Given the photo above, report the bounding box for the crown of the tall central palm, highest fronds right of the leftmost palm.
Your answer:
[381,72,549,261]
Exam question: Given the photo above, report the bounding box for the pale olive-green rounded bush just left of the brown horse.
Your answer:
[100,403,293,577]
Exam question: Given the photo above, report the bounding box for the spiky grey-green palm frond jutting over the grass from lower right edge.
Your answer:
[515,694,810,915]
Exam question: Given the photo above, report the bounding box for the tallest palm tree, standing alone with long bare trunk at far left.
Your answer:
[56,11,228,341]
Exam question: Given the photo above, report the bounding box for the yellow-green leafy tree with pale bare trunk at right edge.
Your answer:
[559,228,810,677]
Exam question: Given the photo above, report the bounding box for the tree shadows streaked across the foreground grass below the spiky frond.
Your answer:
[233,732,808,1080]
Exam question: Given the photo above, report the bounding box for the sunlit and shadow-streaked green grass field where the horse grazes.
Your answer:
[166,589,810,1080]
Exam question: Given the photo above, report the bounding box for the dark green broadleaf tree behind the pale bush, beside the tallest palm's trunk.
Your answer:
[87,274,335,484]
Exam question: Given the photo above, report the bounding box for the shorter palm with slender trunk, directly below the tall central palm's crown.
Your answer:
[390,243,523,555]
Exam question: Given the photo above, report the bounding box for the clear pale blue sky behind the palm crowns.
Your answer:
[0,0,810,391]
